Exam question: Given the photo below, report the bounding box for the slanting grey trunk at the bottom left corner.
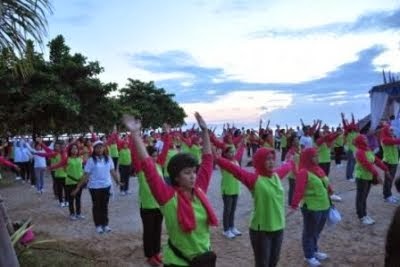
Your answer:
[0,196,19,267]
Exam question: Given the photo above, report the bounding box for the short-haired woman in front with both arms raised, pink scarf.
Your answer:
[124,113,218,267]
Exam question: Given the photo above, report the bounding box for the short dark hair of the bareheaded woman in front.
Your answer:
[167,153,199,186]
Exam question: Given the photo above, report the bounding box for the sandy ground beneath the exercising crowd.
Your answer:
[0,155,396,267]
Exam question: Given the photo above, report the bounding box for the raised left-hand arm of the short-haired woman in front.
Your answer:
[124,116,175,205]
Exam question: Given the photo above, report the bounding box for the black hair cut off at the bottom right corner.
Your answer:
[385,207,400,267]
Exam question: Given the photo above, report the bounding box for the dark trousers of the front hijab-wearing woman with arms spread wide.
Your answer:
[250,229,283,267]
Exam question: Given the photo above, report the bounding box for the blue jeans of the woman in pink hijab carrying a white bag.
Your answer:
[301,208,329,259]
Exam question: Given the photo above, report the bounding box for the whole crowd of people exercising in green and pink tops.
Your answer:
[0,113,400,267]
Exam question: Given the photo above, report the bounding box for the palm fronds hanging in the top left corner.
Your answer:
[0,0,52,56]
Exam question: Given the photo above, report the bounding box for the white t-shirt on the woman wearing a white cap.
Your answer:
[85,157,114,189]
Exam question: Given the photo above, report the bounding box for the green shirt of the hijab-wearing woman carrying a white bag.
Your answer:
[303,172,331,211]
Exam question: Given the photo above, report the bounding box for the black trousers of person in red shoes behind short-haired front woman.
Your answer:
[140,208,163,258]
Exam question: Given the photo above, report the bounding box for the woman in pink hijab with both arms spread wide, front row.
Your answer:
[217,148,294,267]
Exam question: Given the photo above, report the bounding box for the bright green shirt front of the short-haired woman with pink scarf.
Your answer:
[160,196,210,266]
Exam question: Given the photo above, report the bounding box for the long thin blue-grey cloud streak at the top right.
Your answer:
[250,8,400,38]
